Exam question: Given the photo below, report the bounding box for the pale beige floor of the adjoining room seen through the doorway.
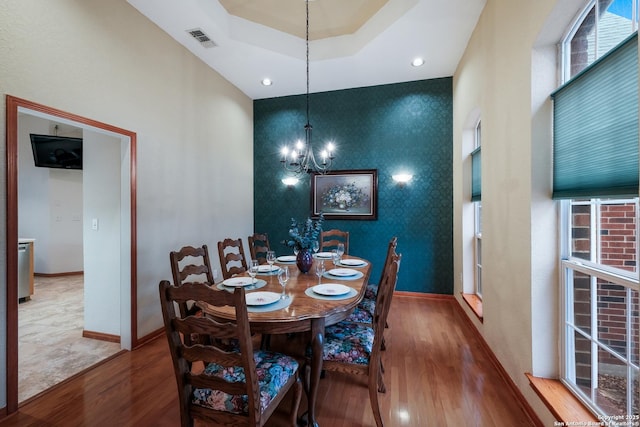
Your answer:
[18,275,120,402]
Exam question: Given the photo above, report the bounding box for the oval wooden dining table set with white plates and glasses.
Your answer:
[202,252,371,427]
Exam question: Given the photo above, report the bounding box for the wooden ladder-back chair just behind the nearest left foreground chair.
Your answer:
[169,245,214,316]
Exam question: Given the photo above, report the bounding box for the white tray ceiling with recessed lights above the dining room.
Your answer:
[127,0,486,99]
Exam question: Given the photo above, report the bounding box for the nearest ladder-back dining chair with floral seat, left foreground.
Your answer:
[159,280,302,427]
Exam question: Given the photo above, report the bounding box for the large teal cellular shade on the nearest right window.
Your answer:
[551,33,638,199]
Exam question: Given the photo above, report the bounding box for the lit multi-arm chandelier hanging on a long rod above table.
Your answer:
[280,0,335,177]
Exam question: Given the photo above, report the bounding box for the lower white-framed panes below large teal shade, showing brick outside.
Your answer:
[562,198,640,416]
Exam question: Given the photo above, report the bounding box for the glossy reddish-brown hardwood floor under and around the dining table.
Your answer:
[0,295,535,427]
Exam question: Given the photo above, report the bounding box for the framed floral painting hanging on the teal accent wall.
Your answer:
[311,169,378,220]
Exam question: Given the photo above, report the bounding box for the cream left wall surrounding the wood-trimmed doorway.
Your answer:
[0,0,253,407]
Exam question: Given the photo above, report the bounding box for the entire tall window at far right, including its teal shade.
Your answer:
[553,0,640,419]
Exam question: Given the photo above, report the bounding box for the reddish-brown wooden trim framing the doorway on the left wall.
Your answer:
[6,95,138,414]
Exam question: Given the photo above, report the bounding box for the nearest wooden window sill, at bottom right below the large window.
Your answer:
[525,373,600,425]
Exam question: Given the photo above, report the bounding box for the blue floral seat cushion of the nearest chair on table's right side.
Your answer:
[322,322,374,365]
